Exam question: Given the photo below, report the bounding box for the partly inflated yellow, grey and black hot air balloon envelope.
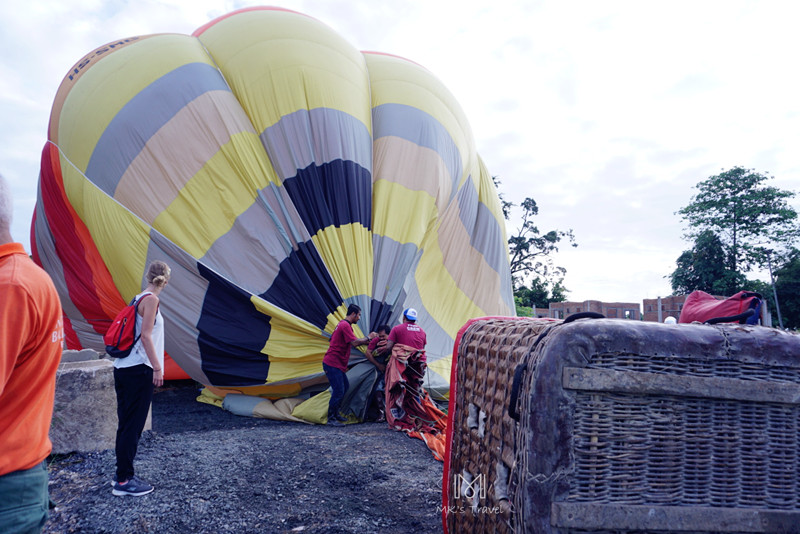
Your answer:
[31,7,514,426]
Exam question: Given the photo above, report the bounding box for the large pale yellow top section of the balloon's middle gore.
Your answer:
[195,11,371,131]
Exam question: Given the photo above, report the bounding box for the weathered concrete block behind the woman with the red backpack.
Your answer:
[50,351,152,454]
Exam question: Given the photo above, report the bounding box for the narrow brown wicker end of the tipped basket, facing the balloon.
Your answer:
[447,319,554,534]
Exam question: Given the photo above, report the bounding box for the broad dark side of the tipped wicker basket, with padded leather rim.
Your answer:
[510,319,800,534]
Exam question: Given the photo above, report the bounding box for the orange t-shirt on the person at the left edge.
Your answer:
[0,243,64,475]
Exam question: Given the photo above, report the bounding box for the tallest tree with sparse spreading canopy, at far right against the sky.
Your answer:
[678,167,800,275]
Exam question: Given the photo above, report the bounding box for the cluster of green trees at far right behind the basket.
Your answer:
[669,167,800,328]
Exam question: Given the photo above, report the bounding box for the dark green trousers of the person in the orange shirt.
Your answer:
[0,462,50,534]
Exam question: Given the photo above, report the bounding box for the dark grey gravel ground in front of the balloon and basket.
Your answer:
[44,381,442,534]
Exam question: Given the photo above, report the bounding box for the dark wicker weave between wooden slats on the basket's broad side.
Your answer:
[568,354,800,510]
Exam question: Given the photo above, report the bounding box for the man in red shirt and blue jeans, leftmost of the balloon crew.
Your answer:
[322,304,374,426]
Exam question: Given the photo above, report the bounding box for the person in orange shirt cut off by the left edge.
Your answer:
[0,176,64,533]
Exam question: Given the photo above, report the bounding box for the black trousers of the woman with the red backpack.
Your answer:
[114,364,153,482]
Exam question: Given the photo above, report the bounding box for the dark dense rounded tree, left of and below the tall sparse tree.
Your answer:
[669,230,745,295]
